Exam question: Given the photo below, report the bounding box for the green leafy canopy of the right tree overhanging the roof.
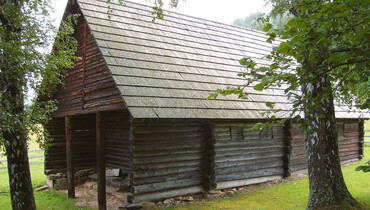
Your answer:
[209,0,370,126]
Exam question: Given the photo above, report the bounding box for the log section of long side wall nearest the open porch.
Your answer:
[129,120,212,202]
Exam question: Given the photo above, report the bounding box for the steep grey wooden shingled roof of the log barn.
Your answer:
[71,0,368,119]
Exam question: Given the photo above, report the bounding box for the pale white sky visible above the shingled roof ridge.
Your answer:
[55,0,271,24]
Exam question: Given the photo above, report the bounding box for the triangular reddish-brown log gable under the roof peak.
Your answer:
[53,15,124,117]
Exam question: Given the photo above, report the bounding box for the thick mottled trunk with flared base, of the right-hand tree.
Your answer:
[303,76,358,209]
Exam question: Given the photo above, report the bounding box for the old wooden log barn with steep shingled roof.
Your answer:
[45,0,370,205]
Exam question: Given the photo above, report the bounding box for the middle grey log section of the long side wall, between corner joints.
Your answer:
[213,121,284,189]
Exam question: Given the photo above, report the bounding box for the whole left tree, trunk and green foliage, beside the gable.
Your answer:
[0,0,76,209]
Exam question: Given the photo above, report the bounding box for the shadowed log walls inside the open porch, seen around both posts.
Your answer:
[45,110,130,174]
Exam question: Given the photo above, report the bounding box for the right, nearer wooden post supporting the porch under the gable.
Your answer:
[96,112,107,210]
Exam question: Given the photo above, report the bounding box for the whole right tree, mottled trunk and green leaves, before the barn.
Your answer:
[212,0,370,209]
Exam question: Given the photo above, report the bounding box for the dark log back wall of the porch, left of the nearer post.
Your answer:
[45,115,96,174]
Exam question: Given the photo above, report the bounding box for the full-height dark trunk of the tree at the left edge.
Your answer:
[0,0,36,210]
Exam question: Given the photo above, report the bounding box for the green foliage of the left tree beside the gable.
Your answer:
[0,0,77,153]
